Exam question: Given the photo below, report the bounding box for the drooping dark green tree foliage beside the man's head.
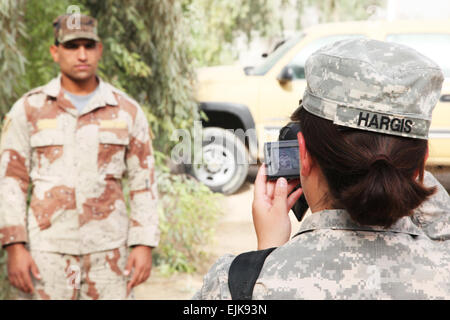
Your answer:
[82,0,199,154]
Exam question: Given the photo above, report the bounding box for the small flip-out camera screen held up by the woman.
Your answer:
[264,140,300,180]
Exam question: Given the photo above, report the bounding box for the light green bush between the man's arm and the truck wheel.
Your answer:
[154,171,222,274]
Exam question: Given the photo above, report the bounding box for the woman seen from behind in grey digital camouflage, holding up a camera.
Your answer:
[194,39,450,299]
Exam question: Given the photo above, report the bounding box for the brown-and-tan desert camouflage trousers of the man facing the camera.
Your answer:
[16,247,134,300]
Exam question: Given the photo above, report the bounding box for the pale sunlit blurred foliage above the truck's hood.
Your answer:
[183,0,286,67]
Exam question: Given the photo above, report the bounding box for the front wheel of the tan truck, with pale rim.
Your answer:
[188,127,249,194]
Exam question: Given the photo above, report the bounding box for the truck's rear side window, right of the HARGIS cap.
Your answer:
[386,33,450,78]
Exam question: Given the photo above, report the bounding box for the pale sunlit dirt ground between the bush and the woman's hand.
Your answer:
[135,172,299,300]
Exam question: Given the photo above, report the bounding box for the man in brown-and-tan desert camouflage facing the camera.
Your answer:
[0,15,159,299]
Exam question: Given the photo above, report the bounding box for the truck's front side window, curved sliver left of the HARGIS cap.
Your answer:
[288,34,364,80]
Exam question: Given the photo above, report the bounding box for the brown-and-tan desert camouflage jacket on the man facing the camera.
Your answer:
[0,77,159,255]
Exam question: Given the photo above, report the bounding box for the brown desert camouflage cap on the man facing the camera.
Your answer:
[53,14,100,43]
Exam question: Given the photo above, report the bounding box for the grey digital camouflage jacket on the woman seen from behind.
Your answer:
[193,172,450,300]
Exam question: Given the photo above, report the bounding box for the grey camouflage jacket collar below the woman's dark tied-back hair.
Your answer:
[294,209,425,237]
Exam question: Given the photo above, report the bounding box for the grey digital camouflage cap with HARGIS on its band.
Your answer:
[302,38,444,139]
